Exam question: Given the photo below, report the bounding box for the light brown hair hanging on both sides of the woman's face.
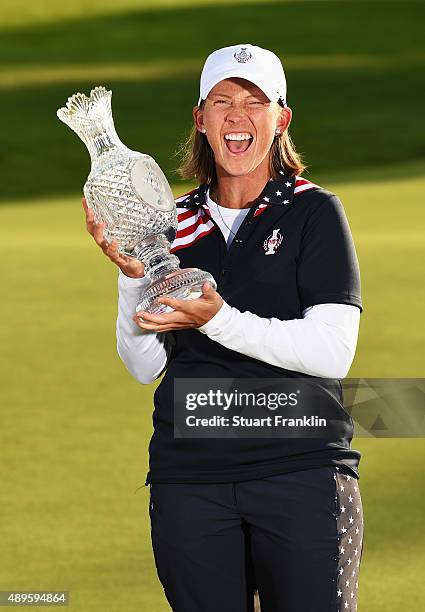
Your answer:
[176,100,306,184]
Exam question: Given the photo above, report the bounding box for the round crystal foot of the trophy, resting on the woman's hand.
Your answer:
[136,268,217,314]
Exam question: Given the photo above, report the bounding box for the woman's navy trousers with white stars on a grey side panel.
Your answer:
[149,466,363,612]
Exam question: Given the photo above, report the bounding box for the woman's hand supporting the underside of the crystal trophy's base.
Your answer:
[133,282,223,332]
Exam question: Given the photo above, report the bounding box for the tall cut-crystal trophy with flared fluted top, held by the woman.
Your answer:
[56,87,217,314]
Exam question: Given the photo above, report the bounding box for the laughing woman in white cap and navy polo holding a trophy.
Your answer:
[86,44,363,612]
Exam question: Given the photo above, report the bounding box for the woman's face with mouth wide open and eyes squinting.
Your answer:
[193,78,291,176]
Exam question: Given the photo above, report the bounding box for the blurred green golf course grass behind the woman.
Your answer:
[0,0,425,612]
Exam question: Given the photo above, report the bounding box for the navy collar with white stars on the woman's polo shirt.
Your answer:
[179,171,295,208]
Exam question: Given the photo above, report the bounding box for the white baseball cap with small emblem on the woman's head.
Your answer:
[198,44,286,106]
